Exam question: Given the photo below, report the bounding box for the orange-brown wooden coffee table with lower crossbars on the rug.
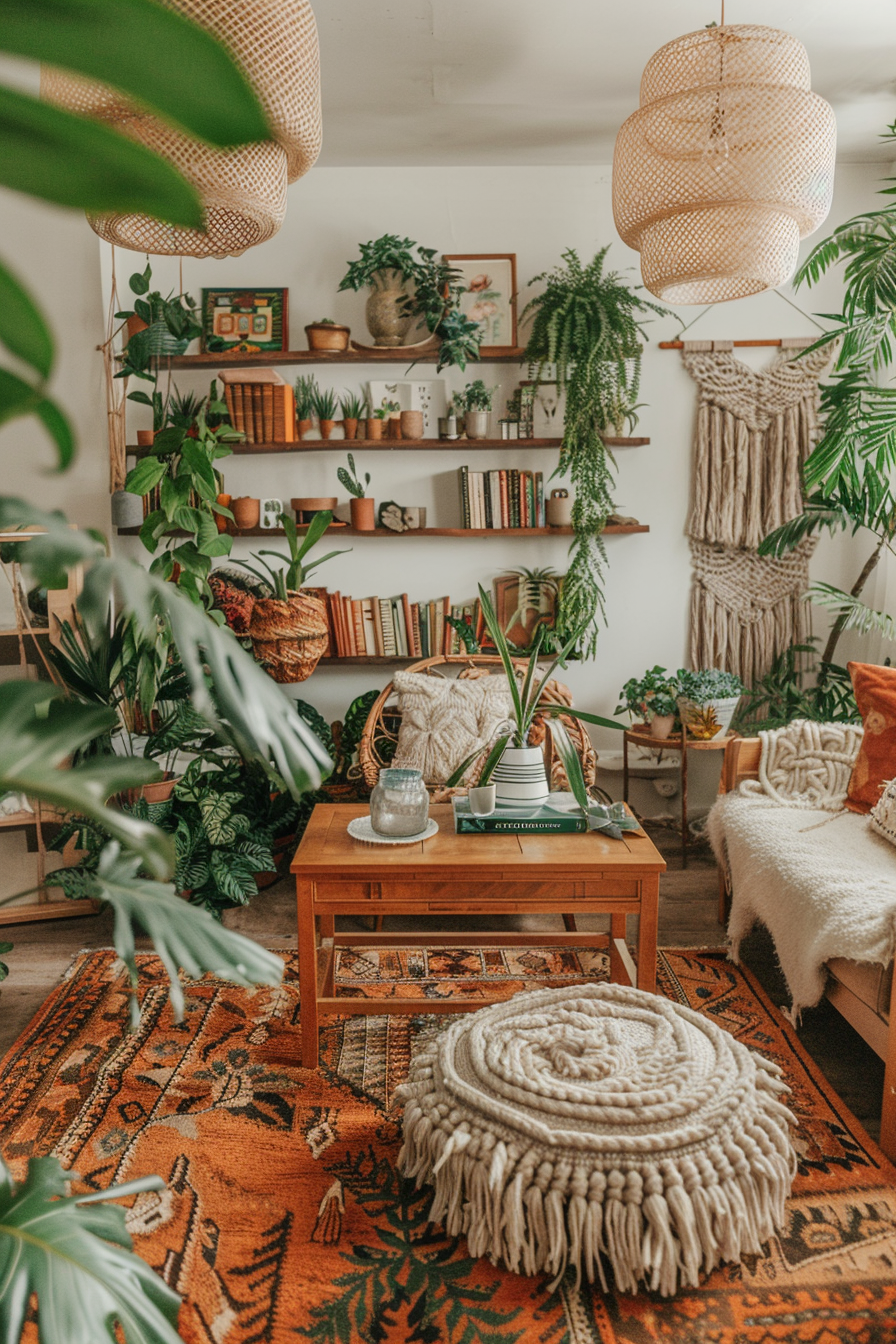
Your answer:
[292,802,666,1068]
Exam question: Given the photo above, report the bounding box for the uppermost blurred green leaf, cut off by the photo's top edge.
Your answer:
[0,0,270,146]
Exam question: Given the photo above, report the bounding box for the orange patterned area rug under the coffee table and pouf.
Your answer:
[0,948,896,1344]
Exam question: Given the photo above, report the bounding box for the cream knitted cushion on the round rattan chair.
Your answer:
[392,672,510,784]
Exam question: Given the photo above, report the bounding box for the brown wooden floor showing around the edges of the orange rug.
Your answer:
[0,827,884,1137]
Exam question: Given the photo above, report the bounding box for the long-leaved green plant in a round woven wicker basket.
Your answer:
[234,509,347,683]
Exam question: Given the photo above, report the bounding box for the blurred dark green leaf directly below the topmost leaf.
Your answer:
[0,82,203,228]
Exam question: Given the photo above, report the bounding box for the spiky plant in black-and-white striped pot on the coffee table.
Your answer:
[446,585,628,835]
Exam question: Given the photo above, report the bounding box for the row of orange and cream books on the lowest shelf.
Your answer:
[326,593,481,659]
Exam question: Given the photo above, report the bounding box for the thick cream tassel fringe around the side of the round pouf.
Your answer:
[399,1096,794,1297]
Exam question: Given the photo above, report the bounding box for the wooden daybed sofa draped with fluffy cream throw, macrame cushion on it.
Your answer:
[708,720,896,1160]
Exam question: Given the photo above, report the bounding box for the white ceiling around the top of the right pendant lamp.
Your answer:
[313,0,896,167]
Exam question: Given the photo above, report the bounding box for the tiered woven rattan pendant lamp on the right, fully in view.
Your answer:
[613,17,837,304]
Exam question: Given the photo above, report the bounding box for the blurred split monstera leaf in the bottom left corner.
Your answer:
[0,1157,181,1344]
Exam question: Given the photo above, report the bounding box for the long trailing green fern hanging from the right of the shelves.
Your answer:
[523,247,669,656]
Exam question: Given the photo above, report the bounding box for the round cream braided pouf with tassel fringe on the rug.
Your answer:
[398,984,797,1296]
